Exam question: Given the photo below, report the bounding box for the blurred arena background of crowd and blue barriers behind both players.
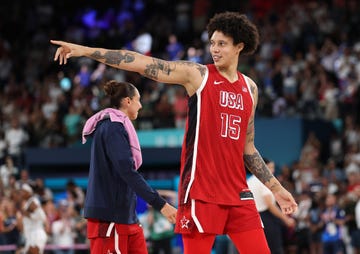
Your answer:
[0,0,360,254]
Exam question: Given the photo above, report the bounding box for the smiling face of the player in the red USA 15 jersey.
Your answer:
[210,31,242,68]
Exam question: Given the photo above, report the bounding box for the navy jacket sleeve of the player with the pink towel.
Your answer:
[103,122,166,210]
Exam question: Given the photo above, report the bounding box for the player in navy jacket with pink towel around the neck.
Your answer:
[83,80,176,254]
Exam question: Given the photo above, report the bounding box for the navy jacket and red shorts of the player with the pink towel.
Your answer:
[84,118,166,254]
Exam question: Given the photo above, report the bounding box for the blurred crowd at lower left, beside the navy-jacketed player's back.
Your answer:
[0,166,88,254]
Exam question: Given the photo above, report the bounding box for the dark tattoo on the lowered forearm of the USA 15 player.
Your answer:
[244,152,274,183]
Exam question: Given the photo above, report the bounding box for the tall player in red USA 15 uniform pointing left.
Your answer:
[51,12,297,254]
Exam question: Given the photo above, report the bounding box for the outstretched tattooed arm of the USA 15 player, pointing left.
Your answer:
[51,40,206,95]
